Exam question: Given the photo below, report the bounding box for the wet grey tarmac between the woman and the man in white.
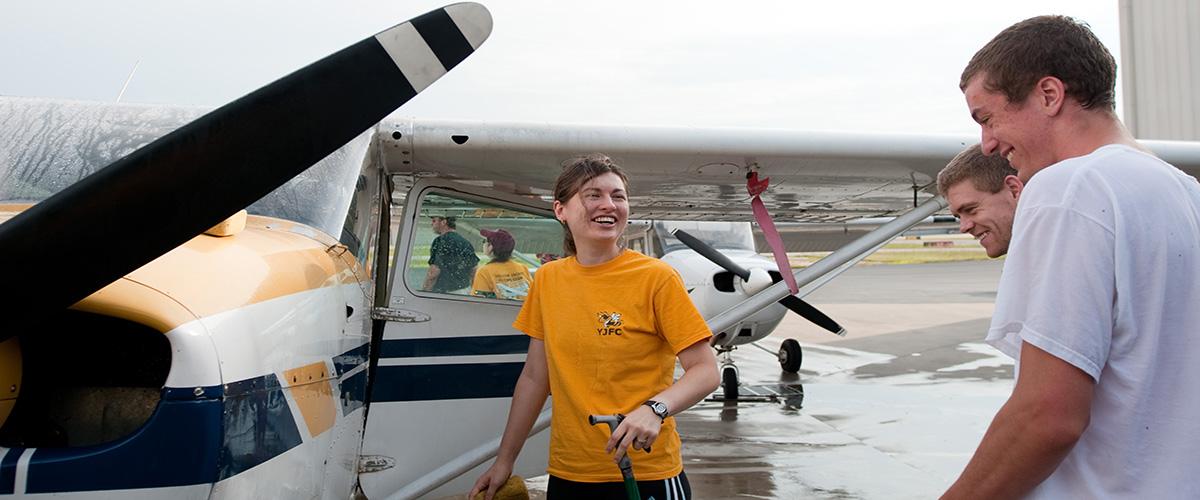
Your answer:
[511,260,1013,499]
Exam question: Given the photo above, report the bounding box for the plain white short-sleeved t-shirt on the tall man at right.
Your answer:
[988,145,1200,499]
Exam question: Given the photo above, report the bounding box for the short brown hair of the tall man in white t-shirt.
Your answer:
[959,16,1117,112]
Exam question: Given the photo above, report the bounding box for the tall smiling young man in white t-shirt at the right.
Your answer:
[946,16,1200,499]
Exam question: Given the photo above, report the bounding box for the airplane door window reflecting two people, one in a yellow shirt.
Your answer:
[404,193,563,301]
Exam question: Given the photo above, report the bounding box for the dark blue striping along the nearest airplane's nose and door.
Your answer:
[10,336,501,494]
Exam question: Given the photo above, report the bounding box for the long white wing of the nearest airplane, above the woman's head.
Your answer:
[378,119,1200,223]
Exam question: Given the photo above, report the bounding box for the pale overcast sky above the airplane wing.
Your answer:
[0,0,1121,133]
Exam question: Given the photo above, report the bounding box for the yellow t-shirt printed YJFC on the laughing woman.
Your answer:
[512,251,712,482]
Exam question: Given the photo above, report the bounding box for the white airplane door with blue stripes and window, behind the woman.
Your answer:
[359,180,563,498]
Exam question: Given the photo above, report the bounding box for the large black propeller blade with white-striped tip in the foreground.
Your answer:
[0,4,492,341]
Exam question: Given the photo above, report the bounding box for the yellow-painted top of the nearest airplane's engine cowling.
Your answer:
[72,216,360,332]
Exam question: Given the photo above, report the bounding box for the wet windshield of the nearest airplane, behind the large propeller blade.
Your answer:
[0,98,368,237]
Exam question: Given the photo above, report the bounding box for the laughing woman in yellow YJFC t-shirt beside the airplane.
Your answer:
[470,155,720,500]
